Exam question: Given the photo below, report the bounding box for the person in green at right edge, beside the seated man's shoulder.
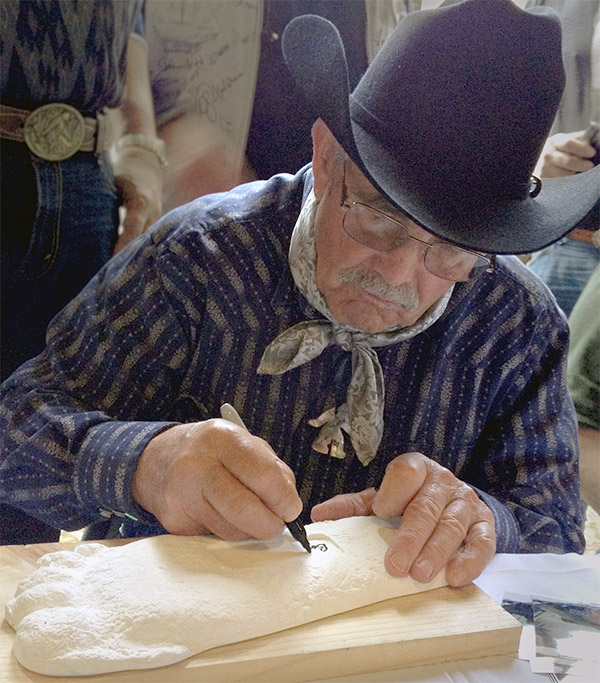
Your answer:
[567,266,600,512]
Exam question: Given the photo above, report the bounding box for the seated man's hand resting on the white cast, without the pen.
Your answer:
[311,453,496,586]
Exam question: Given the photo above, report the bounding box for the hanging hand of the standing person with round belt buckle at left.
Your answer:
[113,146,162,254]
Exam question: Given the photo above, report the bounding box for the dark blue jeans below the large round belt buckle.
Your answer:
[0,140,119,379]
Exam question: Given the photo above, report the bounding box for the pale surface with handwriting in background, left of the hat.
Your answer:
[146,0,262,140]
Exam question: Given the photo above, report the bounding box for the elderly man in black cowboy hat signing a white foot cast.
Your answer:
[0,0,600,585]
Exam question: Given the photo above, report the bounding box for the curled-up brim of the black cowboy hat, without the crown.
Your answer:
[282,10,600,254]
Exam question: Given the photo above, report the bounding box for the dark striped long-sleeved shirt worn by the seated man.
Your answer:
[0,169,584,552]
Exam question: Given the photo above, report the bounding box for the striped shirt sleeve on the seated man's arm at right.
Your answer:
[463,292,585,553]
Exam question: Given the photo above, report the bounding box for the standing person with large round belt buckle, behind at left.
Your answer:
[0,0,164,543]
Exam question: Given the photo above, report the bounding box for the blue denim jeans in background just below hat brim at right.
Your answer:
[529,237,600,317]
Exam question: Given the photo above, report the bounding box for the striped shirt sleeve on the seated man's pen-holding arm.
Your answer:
[0,212,192,529]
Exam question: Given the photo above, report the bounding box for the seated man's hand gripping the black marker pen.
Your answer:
[132,419,302,541]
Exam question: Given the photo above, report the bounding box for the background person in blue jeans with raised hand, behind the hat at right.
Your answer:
[527,0,600,317]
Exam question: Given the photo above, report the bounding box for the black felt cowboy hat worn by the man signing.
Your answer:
[282,0,600,254]
